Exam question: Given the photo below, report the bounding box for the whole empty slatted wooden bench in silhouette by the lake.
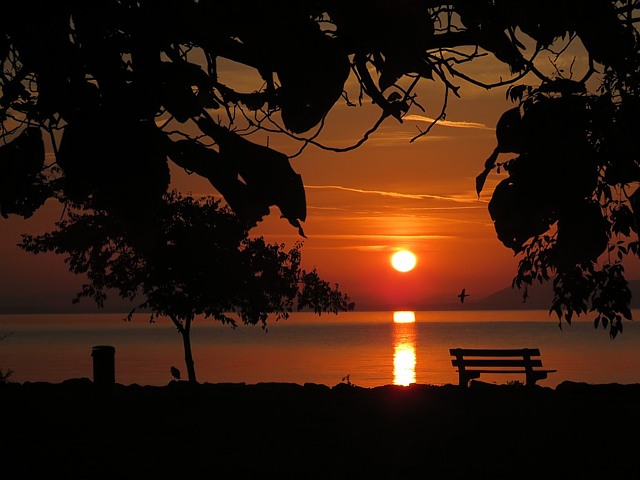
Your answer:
[449,348,556,387]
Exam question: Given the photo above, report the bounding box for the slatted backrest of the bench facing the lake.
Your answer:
[449,348,542,370]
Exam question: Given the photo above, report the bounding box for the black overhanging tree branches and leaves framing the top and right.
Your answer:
[0,0,640,336]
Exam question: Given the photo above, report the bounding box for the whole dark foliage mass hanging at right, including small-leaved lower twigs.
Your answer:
[488,80,640,337]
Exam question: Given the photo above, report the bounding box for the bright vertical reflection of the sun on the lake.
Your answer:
[393,312,416,387]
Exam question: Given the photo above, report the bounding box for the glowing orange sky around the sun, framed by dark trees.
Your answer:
[174,78,516,310]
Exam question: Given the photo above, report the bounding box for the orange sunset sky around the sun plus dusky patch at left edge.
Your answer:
[0,38,636,311]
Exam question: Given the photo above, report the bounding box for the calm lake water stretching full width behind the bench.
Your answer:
[0,311,640,387]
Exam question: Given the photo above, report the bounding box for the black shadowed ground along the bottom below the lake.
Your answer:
[0,379,640,480]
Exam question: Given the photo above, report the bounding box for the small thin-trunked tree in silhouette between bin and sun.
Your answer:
[19,191,354,383]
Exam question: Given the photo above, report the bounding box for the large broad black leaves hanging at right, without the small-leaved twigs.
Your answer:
[488,95,601,252]
